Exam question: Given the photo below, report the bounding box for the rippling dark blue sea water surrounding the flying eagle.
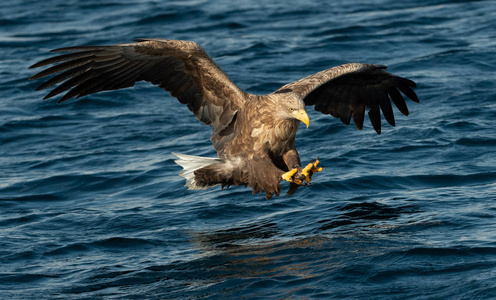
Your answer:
[0,0,496,299]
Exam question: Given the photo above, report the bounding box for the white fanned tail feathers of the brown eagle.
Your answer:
[172,152,222,190]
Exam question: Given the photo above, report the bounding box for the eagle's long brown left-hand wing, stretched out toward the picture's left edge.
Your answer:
[30,39,244,150]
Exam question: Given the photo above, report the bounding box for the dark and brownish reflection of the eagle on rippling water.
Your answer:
[180,202,422,288]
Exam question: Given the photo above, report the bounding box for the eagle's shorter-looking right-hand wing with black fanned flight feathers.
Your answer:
[274,63,419,134]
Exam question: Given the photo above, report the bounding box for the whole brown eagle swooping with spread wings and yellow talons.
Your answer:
[31,39,418,199]
